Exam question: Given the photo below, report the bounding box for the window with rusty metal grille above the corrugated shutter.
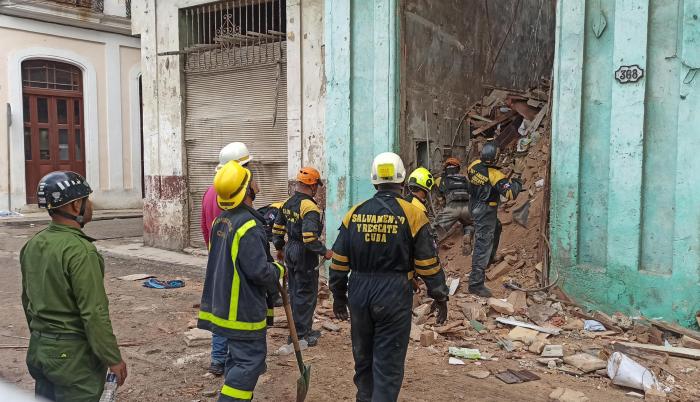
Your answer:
[178,0,287,71]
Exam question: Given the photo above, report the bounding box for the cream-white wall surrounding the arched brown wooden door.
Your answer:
[0,15,141,210]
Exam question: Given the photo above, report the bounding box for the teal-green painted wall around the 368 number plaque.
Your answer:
[550,0,700,325]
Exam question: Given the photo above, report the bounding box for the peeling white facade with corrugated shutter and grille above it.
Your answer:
[133,0,325,249]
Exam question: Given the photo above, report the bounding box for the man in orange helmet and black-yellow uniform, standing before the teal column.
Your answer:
[272,167,333,346]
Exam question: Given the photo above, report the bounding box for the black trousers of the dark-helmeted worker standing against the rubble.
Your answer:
[469,202,502,287]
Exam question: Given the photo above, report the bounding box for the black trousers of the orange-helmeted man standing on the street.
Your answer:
[284,240,318,339]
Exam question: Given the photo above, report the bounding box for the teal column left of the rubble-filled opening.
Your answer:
[325,0,399,245]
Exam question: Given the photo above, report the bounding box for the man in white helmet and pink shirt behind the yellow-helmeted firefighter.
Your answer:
[200,142,279,376]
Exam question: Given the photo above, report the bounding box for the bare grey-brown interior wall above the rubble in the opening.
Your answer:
[400,0,555,170]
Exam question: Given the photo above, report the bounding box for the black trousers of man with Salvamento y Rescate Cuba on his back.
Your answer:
[348,271,413,402]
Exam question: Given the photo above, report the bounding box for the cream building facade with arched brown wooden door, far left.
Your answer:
[0,0,142,211]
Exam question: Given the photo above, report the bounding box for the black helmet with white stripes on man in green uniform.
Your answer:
[36,171,92,227]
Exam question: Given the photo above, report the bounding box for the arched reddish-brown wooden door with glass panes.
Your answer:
[22,60,85,204]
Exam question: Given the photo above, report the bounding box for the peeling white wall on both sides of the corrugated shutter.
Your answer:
[132,0,325,249]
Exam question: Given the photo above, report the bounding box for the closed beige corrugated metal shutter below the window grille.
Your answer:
[185,61,287,247]
